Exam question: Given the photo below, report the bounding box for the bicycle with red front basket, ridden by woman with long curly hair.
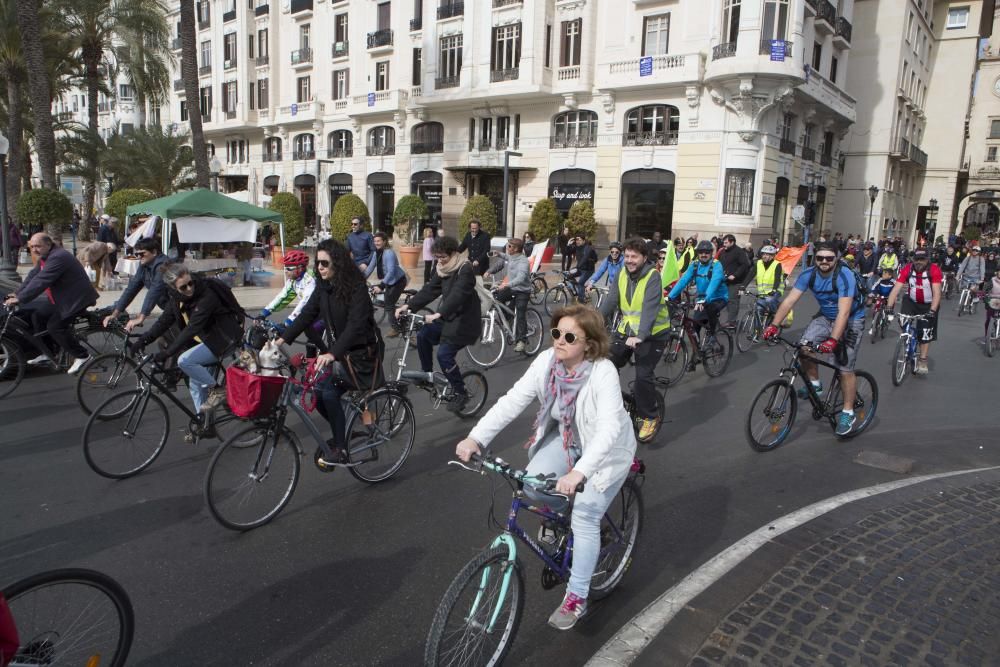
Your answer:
[204,354,417,531]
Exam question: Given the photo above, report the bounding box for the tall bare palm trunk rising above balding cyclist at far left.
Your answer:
[17,0,56,189]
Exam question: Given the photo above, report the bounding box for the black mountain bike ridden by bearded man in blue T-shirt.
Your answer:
[746,337,878,452]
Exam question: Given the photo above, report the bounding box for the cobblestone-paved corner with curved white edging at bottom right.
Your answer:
[588,469,1000,667]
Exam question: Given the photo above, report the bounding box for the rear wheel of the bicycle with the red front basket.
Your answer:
[347,389,417,484]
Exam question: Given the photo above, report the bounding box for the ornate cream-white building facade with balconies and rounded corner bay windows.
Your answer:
[161,0,855,242]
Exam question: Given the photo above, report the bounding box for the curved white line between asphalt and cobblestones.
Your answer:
[585,466,1000,667]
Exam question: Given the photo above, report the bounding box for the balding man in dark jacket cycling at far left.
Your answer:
[4,232,97,375]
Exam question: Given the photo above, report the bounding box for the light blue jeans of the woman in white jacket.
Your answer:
[525,429,628,599]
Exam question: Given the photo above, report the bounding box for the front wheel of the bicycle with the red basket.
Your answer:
[205,424,301,531]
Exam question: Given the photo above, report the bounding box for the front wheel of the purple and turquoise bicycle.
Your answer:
[424,546,524,666]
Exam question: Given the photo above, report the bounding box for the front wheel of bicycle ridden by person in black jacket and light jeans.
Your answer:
[83,389,170,479]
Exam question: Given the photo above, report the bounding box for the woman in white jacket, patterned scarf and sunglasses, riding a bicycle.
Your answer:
[455,304,636,630]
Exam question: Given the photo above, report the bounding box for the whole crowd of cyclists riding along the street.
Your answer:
[4,219,1000,630]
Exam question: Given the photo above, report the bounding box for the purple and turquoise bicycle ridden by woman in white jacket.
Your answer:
[424,455,645,667]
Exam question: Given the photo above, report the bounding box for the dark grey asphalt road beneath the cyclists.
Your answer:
[0,294,1000,666]
